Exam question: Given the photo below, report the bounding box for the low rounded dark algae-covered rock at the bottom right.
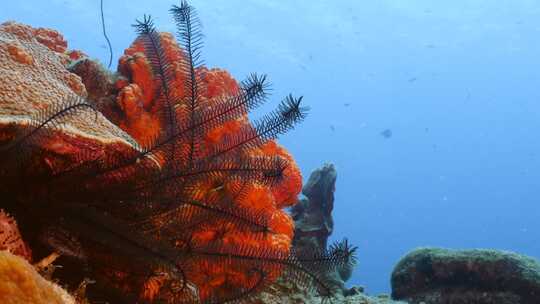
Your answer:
[392,248,540,304]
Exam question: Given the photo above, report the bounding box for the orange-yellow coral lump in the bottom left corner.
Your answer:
[0,251,75,304]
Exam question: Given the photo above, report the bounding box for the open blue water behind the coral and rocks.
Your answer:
[0,0,540,293]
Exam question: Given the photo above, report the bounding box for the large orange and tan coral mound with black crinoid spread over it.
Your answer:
[0,1,355,303]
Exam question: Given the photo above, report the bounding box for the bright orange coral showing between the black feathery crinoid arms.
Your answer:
[113,33,302,299]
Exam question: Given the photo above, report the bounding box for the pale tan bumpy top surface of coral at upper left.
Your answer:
[0,22,137,151]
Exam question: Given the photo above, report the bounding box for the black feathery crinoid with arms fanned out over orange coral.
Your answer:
[0,1,355,303]
